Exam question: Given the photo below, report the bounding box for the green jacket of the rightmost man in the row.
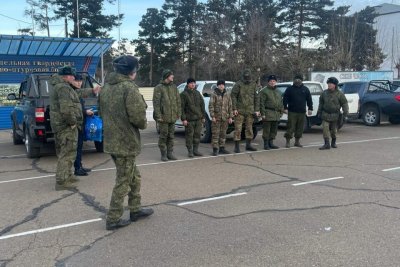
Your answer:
[317,89,349,121]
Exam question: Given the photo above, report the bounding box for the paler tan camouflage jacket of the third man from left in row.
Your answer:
[208,88,233,121]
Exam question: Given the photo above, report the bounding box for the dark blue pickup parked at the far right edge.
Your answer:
[339,80,400,126]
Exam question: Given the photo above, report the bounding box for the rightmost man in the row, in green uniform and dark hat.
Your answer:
[318,77,349,150]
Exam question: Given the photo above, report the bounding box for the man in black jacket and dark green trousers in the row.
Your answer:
[283,75,313,148]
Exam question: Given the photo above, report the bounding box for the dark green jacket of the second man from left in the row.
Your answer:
[181,86,206,121]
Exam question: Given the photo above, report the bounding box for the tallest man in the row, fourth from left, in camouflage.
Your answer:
[231,69,260,153]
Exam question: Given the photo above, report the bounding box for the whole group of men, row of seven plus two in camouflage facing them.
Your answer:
[50,56,348,230]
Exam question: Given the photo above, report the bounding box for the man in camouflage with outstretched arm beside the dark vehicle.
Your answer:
[50,66,99,193]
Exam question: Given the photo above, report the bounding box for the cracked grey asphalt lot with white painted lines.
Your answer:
[0,123,400,266]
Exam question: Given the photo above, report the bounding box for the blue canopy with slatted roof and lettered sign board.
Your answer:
[0,35,114,83]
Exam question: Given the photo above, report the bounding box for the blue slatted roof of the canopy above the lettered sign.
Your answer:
[0,35,114,57]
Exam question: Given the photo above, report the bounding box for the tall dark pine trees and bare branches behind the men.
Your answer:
[22,0,384,86]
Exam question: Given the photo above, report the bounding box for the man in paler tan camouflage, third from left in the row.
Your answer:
[208,80,233,156]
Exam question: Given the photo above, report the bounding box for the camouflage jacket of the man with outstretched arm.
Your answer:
[50,74,92,133]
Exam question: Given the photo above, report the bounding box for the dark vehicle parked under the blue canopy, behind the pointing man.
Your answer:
[7,72,103,158]
